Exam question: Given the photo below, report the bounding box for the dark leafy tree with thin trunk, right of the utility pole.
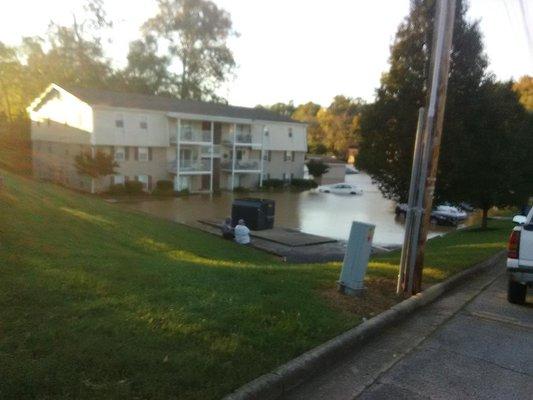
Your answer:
[438,79,533,228]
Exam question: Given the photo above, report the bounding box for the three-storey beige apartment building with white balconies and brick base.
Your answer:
[28,84,307,192]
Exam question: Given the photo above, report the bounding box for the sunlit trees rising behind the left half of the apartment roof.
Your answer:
[0,0,236,124]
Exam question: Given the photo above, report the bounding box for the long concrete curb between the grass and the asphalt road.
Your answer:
[224,251,505,400]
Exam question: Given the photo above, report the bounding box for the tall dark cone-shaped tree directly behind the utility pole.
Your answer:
[358,0,487,202]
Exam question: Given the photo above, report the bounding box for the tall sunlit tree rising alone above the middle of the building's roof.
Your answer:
[143,0,236,100]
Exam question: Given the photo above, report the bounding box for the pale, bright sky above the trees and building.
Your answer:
[0,0,533,106]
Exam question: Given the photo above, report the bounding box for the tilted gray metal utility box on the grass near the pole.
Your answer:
[338,221,376,296]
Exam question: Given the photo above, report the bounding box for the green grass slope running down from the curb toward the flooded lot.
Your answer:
[0,171,510,399]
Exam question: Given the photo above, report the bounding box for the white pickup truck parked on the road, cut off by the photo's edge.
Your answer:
[507,208,533,304]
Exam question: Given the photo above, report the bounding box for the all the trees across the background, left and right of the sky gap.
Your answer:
[0,0,533,225]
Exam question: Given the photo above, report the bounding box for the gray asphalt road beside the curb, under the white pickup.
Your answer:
[285,264,533,400]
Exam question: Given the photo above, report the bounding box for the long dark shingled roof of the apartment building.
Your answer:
[61,85,298,122]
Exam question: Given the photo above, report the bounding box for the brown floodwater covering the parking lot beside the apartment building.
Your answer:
[124,174,470,246]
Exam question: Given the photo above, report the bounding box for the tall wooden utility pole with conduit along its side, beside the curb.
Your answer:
[398,0,455,295]
